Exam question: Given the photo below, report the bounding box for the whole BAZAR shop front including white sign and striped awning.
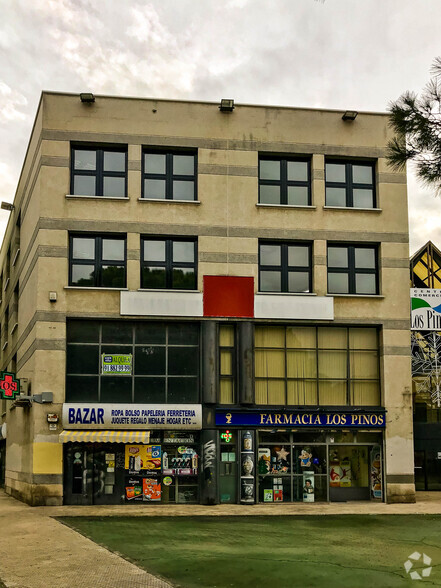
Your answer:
[60,403,202,504]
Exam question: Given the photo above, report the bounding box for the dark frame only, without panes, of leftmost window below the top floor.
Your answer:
[69,233,127,290]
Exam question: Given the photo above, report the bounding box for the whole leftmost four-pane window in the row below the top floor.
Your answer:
[69,235,126,288]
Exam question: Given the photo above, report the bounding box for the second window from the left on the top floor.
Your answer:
[142,150,197,200]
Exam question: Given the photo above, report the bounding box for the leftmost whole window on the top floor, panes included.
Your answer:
[70,147,127,198]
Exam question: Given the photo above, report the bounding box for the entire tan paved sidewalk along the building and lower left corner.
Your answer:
[0,491,441,588]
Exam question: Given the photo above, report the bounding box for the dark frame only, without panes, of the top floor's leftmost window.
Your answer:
[70,143,128,198]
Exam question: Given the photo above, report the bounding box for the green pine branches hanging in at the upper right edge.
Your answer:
[387,57,441,194]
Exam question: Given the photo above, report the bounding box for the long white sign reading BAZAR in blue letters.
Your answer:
[63,403,202,429]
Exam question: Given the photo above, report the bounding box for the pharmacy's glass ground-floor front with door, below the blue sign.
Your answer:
[219,429,384,503]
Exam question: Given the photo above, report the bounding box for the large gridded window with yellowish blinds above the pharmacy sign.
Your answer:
[255,326,380,406]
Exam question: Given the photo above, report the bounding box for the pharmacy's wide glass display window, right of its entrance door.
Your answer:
[257,431,382,502]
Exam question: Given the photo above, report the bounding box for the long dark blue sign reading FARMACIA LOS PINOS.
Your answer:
[216,410,386,429]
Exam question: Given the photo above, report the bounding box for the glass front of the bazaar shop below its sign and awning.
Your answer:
[63,431,200,504]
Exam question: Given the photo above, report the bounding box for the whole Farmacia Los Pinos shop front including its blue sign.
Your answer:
[216,410,385,503]
